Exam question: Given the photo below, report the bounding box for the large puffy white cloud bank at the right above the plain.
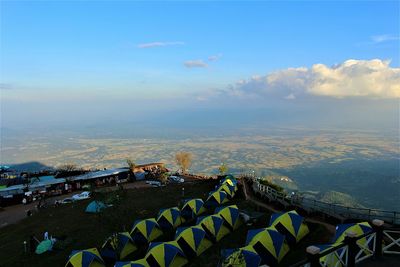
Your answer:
[225,59,400,99]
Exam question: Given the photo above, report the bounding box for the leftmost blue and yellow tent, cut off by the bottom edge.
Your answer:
[65,248,105,267]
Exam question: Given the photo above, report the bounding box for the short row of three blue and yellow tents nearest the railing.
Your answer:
[220,210,310,267]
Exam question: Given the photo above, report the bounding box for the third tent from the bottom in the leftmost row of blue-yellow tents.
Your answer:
[130,218,163,244]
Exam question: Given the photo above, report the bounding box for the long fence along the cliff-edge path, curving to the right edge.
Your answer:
[242,175,400,228]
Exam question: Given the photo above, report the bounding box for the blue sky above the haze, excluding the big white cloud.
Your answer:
[0,1,399,130]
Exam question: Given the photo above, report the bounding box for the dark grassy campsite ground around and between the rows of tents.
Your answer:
[0,180,330,267]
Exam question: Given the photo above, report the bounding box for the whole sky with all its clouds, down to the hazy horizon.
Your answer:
[0,1,400,133]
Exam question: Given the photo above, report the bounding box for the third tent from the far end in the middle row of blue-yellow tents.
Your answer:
[175,226,212,258]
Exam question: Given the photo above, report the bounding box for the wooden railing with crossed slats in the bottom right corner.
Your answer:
[291,220,400,267]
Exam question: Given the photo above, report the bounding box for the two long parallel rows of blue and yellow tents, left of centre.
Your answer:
[66,175,240,267]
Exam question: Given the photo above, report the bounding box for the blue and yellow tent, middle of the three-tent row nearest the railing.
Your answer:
[246,227,289,265]
